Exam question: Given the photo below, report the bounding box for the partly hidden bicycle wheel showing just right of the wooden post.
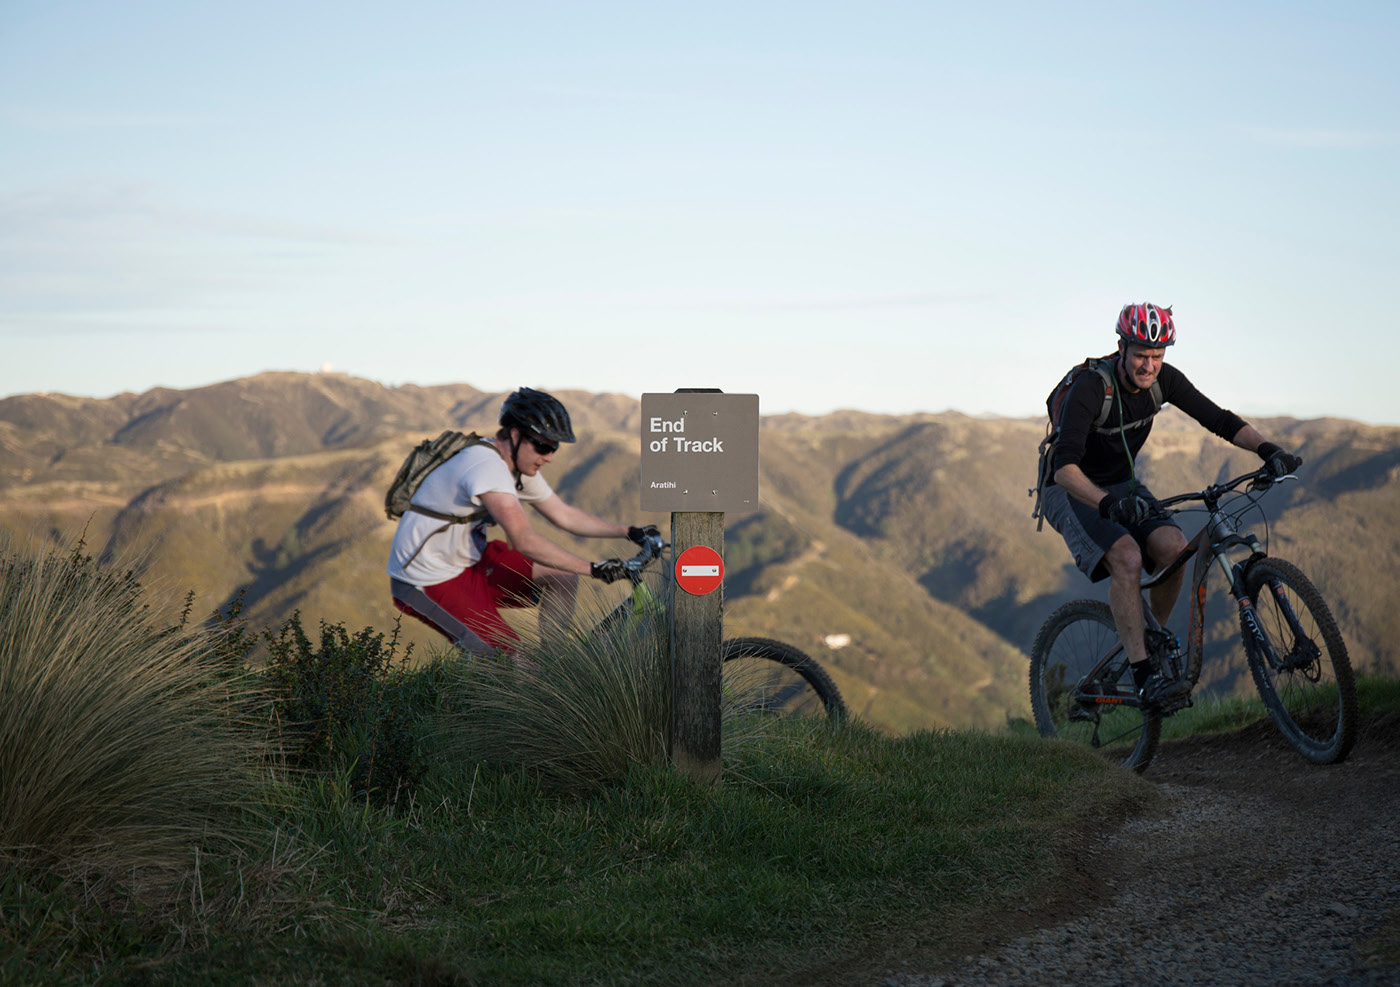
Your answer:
[721,637,846,720]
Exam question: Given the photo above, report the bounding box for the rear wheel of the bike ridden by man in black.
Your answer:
[1030,599,1162,773]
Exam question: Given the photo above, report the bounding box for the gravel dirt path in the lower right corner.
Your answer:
[868,714,1400,987]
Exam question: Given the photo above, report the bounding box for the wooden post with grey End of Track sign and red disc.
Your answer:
[641,388,759,781]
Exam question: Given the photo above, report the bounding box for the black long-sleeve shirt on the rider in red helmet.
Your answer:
[1054,360,1245,487]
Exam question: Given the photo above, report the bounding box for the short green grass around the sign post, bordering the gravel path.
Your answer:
[13,725,1152,984]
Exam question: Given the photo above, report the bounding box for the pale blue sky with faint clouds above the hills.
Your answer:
[0,0,1400,424]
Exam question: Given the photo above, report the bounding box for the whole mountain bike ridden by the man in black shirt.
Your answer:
[1030,469,1359,771]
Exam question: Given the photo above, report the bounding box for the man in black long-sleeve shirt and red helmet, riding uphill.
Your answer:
[1044,302,1302,701]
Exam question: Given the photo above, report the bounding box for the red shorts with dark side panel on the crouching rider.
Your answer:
[393,540,540,648]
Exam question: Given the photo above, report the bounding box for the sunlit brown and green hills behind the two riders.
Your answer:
[0,372,1400,729]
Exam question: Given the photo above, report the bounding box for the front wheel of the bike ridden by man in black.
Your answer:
[1240,559,1357,764]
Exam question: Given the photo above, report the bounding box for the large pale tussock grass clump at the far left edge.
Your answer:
[0,534,258,871]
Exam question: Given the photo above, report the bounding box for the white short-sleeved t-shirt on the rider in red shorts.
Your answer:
[388,445,554,588]
